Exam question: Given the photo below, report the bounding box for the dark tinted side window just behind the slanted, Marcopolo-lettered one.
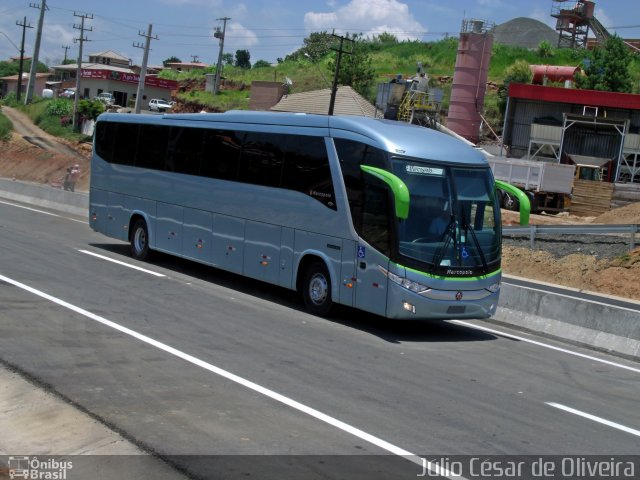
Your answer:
[238,132,287,187]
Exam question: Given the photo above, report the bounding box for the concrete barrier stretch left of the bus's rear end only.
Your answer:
[0,178,89,217]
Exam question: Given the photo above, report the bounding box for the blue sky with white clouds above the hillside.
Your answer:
[0,0,640,65]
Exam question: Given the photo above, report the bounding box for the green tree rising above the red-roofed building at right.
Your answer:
[576,35,633,93]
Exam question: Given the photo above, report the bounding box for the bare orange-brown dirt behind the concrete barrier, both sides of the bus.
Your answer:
[0,107,640,300]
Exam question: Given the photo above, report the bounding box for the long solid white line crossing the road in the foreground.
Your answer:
[0,275,465,480]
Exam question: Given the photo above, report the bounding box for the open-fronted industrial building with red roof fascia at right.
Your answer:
[503,83,640,184]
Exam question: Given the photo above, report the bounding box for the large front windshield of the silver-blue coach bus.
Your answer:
[392,157,500,276]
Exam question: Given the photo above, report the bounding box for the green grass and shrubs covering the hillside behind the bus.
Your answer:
[162,38,640,117]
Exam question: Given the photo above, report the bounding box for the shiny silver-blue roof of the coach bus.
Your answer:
[100,110,488,166]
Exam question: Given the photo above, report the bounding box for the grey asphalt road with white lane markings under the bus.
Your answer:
[0,198,640,478]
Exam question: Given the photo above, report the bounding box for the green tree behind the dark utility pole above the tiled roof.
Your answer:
[328,34,375,97]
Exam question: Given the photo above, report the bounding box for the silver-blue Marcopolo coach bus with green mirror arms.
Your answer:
[89,111,508,319]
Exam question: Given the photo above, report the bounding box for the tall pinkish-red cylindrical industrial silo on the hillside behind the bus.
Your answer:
[447,20,493,143]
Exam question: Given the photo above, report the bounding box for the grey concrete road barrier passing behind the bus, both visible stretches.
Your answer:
[0,179,640,360]
